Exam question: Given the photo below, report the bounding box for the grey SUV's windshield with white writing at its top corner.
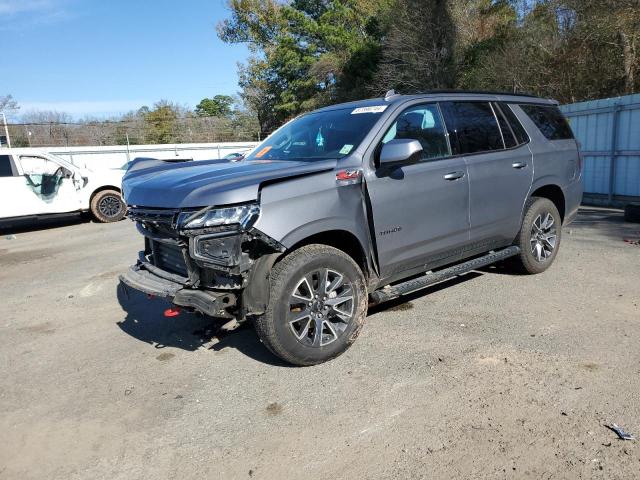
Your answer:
[247,105,387,160]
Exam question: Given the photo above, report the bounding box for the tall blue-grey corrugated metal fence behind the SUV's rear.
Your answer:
[561,94,640,206]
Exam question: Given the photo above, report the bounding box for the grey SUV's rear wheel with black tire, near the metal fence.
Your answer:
[510,197,562,274]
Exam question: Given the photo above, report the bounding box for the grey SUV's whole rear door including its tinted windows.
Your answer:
[441,101,533,244]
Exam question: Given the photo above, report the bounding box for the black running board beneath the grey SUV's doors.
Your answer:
[371,246,520,304]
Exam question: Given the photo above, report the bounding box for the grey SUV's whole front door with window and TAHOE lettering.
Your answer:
[366,103,469,278]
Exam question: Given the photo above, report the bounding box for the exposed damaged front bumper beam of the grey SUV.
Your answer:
[120,261,236,318]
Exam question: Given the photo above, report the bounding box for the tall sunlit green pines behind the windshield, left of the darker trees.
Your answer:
[218,0,395,133]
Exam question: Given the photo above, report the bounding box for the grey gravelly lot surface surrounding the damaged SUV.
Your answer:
[0,209,640,479]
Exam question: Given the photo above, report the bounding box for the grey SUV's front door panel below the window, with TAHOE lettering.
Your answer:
[367,158,469,277]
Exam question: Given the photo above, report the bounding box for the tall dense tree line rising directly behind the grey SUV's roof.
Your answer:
[218,0,640,131]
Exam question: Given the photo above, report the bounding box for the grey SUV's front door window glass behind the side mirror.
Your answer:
[382,104,450,160]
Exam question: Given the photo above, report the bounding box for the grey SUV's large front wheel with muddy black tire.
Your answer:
[255,245,367,366]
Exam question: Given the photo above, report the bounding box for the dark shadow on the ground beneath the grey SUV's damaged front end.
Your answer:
[117,284,291,367]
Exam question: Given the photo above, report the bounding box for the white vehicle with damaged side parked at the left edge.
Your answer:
[0,148,126,223]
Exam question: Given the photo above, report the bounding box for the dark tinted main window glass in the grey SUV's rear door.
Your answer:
[440,102,504,155]
